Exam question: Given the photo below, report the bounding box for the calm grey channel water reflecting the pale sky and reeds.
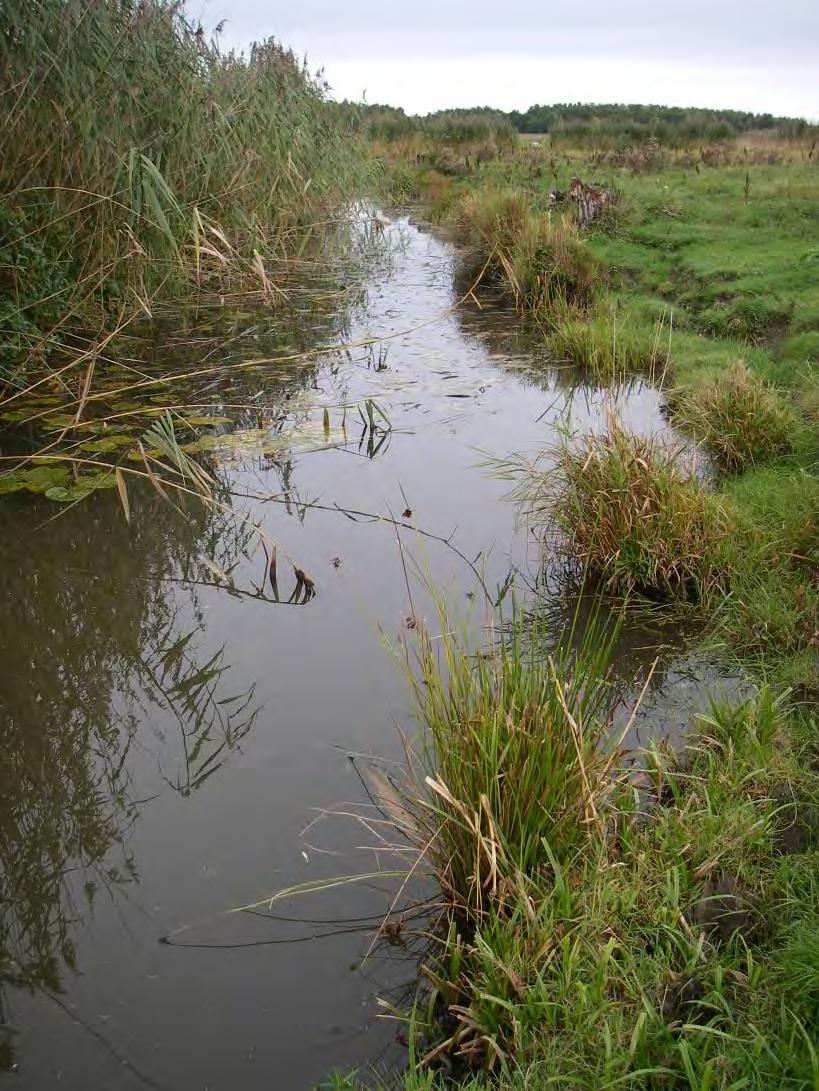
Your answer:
[0,210,741,1091]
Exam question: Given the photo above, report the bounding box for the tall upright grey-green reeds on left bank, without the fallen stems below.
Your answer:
[0,0,363,380]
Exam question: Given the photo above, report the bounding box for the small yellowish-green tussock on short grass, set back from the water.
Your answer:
[670,360,799,472]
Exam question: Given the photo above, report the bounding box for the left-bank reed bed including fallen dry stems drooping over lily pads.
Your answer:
[0,0,371,500]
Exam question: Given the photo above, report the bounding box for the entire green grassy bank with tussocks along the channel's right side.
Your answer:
[329,132,819,1091]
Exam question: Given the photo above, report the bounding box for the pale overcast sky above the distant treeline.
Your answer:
[194,0,819,120]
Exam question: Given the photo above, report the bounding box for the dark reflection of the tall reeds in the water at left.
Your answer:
[0,495,258,1069]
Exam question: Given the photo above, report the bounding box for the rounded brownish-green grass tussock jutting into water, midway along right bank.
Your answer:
[521,420,728,600]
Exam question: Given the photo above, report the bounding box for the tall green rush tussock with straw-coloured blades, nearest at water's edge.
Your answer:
[399,604,613,923]
